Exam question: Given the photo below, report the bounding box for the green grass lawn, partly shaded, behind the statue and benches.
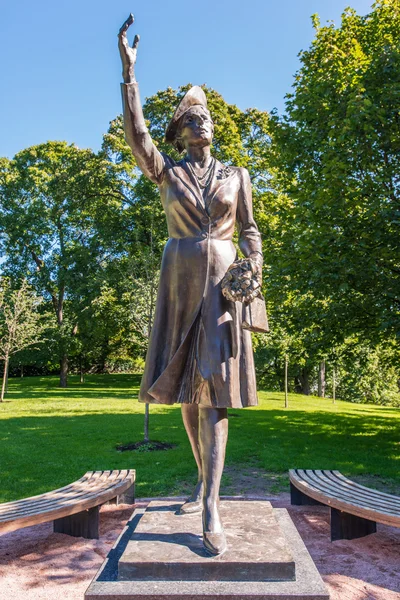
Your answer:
[0,375,400,502]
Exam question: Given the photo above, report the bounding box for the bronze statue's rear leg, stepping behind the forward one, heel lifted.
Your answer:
[180,404,203,514]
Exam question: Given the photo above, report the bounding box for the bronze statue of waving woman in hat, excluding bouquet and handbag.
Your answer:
[119,15,262,555]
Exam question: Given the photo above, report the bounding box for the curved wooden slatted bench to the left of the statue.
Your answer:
[0,469,135,539]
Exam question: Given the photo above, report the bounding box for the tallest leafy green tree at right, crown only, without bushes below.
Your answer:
[271,0,400,344]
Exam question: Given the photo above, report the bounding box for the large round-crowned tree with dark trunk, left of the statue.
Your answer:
[0,142,125,387]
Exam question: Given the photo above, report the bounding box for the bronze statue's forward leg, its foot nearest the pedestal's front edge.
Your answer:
[199,405,228,554]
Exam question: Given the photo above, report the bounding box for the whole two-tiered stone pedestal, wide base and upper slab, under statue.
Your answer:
[85,501,329,600]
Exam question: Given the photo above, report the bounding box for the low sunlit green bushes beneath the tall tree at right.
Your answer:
[254,321,400,406]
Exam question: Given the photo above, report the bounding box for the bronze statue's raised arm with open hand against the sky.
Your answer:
[118,14,165,183]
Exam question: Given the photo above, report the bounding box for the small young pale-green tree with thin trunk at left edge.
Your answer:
[0,277,45,402]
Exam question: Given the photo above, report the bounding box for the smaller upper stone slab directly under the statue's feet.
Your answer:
[118,501,295,581]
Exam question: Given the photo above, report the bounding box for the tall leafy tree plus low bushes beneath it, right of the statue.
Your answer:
[256,0,400,405]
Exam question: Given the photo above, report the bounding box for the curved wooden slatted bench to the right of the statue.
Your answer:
[289,469,400,541]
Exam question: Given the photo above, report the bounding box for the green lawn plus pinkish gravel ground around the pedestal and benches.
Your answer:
[0,375,400,600]
